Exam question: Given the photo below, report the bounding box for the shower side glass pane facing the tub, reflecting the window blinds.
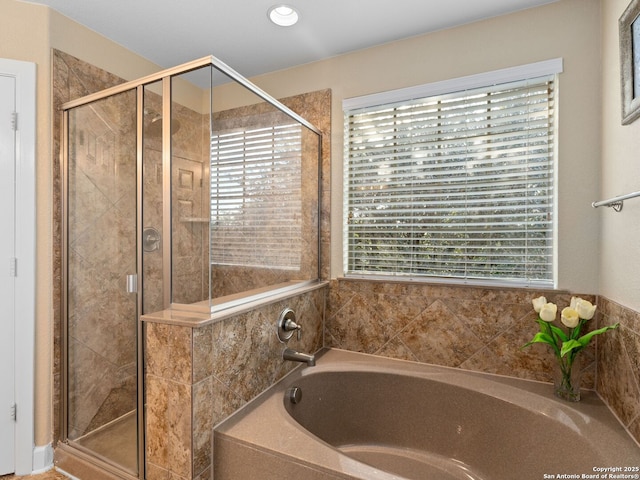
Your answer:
[210,66,320,304]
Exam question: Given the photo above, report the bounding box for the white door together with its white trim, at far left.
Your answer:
[0,59,35,475]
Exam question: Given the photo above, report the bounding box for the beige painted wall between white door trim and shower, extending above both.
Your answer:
[0,0,165,452]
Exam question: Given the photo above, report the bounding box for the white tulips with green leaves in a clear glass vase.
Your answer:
[522,297,618,402]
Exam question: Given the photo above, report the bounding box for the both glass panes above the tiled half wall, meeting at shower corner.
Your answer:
[165,67,320,310]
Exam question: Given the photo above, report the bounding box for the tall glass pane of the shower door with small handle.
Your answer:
[67,91,138,474]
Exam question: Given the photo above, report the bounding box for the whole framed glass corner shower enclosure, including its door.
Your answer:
[61,57,320,478]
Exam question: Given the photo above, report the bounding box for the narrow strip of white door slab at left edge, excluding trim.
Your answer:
[0,73,16,475]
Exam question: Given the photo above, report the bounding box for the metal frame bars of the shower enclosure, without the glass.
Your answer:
[58,56,321,479]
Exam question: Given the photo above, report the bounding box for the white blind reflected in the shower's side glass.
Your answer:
[211,124,302,269]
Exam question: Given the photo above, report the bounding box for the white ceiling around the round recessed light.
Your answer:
[22,0,557,77]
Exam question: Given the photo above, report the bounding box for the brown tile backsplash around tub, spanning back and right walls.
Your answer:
[325,279,640,441]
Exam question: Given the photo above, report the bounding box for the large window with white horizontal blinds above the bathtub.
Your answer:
[344,60,562,286]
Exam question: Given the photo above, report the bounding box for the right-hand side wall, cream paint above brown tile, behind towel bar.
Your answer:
[597,0,640,439]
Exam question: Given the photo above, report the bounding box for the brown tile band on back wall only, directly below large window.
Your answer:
[325,279,596,389]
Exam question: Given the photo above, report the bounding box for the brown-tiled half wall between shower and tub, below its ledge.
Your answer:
[145,285,327,480]
